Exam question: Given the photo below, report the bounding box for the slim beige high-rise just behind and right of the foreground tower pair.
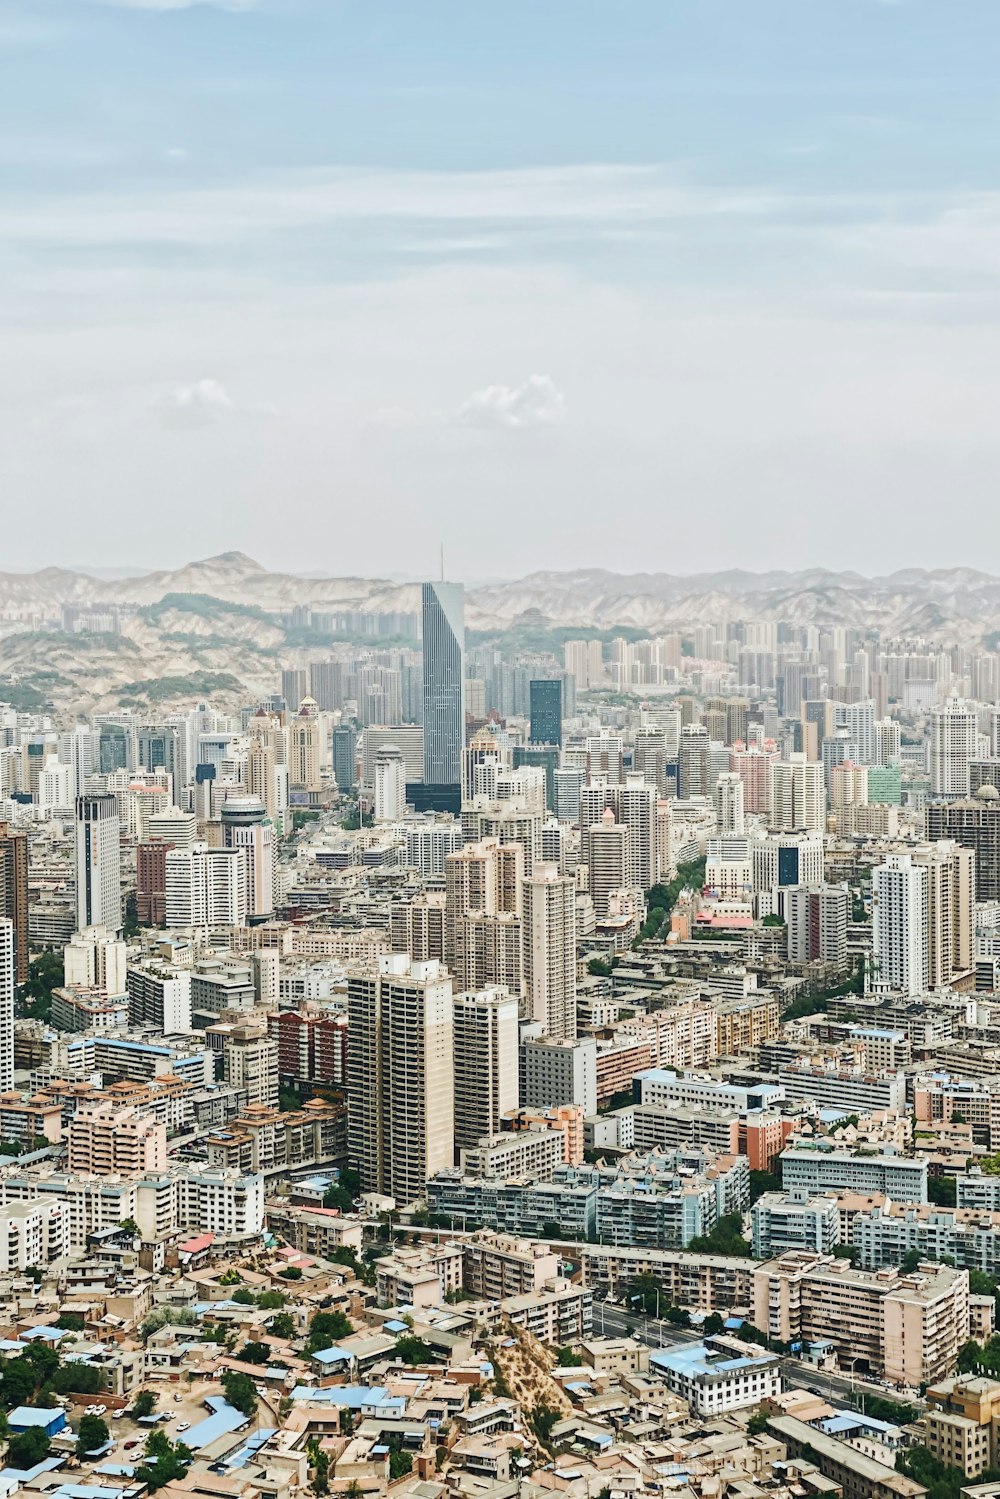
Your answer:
[522,863,576,1040]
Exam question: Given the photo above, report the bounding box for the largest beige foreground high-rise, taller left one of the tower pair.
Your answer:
[348,953,454,1204]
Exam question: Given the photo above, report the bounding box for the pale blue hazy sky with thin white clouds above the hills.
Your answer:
[0,0,1000,577]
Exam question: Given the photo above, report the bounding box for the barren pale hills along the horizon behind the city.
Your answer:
[0,552,1000,714]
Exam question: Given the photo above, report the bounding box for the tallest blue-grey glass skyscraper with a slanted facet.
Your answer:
[423,583,465,794]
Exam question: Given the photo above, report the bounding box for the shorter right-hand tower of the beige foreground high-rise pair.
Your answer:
[454,988,519,1148]
